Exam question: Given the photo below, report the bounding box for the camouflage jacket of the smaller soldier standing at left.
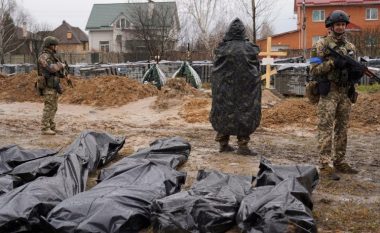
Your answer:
[38,49,63,78]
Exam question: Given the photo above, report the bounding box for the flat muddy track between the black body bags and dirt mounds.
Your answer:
[0,97,380,232]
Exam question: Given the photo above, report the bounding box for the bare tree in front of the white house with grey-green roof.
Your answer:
[130,2,179,57]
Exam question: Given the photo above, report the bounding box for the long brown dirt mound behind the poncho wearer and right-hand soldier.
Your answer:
[180,92,380,128]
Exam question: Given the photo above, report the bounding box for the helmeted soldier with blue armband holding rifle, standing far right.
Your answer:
[310,10,358,180]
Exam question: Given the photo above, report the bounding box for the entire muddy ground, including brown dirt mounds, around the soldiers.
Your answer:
[0,75,380,232]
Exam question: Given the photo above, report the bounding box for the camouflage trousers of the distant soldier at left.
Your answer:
[41,88,58,131]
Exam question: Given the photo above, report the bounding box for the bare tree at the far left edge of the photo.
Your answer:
[0,0,27,64]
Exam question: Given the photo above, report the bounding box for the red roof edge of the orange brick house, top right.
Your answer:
[294,0,380,11]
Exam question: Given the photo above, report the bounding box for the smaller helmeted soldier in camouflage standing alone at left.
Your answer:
[38,36,68,135]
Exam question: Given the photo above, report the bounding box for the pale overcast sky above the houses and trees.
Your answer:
[16,0,296,33]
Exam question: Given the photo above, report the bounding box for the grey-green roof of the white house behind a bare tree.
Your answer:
[86,2,179,30]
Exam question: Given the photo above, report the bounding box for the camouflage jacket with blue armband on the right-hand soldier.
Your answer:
[310,35,356,83]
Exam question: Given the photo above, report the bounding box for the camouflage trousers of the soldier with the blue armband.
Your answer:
[318,84,351,166]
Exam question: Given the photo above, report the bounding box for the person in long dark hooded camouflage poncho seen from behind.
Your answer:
[210,19,261,155]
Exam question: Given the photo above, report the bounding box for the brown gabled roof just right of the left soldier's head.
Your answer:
[52,20,88,44]
